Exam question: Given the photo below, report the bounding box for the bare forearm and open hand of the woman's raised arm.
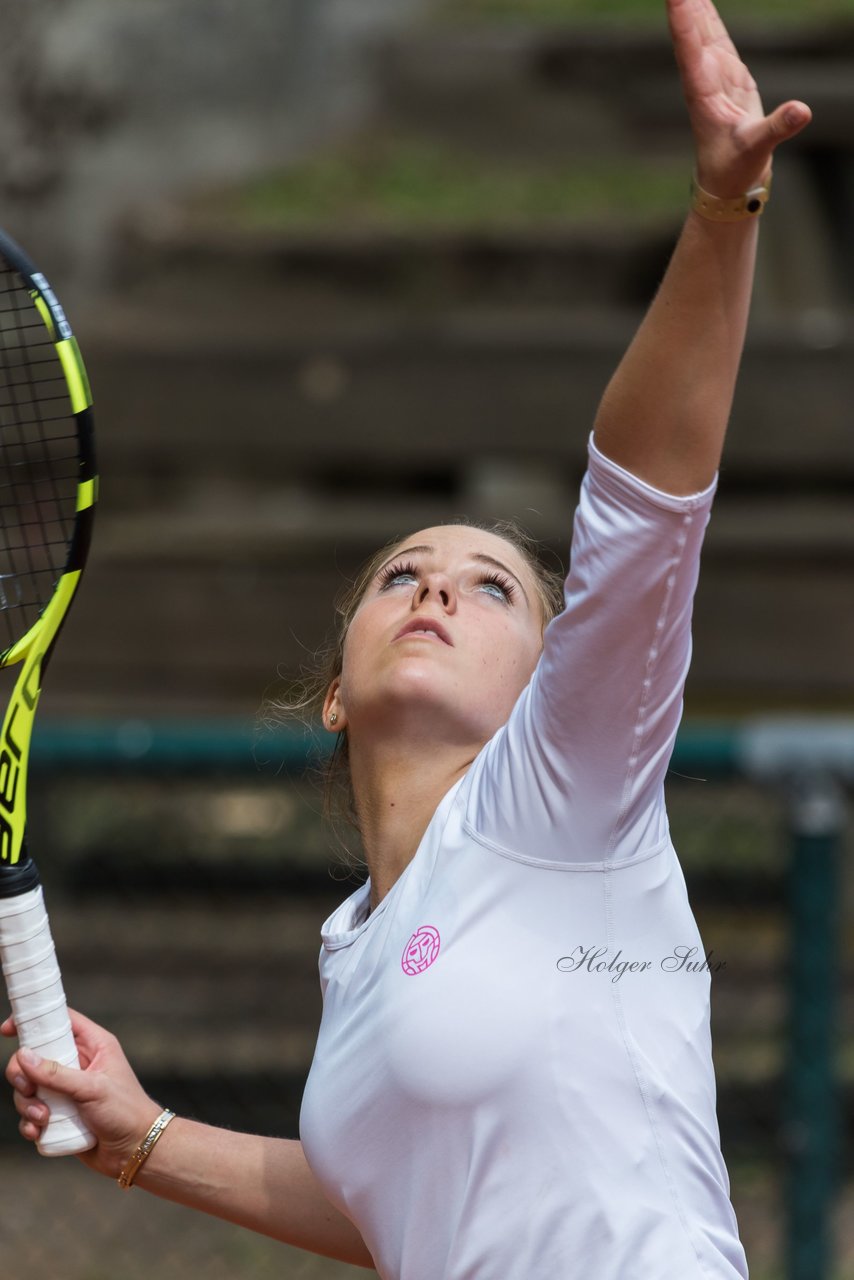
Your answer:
[594,0,810,494]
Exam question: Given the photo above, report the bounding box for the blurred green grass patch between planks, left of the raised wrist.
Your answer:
[207,137,686,230]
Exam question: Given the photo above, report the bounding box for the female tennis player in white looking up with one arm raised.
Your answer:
[3,0,810,1280]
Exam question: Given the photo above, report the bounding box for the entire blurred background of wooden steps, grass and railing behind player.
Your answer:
[0,0,854,1280]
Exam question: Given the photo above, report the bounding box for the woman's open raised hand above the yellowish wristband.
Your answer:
[667,0,812,200]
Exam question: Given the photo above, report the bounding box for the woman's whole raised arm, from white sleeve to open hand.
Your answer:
[466,0,810,867]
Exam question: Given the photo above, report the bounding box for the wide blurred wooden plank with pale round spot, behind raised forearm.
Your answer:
[87,315,854,485]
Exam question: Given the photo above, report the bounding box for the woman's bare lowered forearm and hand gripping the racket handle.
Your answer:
[0,1011,374,1271]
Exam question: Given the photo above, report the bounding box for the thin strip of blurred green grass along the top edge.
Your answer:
[434,0,854,26]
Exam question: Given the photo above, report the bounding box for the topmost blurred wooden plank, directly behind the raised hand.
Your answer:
[376,22,854,156]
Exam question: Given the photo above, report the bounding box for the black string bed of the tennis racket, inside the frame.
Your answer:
[0,264,79,648]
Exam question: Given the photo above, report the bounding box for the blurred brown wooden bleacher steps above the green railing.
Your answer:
[50,17,854,716]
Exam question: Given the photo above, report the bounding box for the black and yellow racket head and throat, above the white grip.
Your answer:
[0,232,97,870]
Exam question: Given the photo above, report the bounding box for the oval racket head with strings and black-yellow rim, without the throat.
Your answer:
[0,230,97,671]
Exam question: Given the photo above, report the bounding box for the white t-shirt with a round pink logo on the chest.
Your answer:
[300,436,748,1280]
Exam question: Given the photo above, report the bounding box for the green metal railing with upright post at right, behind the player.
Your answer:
[25,717,854,1280]
